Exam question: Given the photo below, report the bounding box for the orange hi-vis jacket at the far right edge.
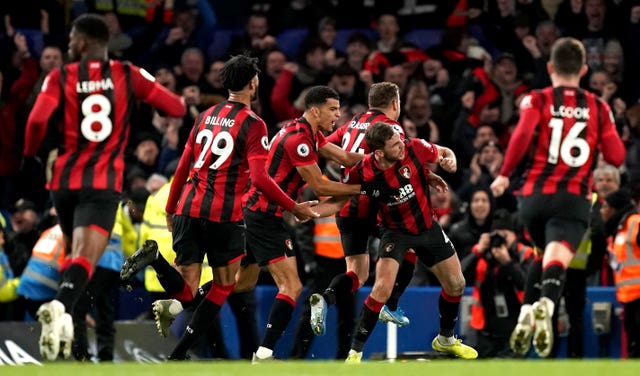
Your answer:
[611,213,640,303]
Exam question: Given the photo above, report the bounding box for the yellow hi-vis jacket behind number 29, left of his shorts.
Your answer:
[139,178,213,292]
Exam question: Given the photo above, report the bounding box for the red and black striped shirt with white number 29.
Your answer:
[167,101,269,222]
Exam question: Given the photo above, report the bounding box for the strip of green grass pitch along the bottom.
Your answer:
[0,359,640,376]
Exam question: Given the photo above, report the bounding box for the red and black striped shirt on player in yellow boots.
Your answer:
[348,138,438,235]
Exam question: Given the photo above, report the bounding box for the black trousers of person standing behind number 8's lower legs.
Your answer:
[72,267,120,362]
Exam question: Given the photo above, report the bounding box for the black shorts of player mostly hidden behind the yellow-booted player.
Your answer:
[336,217,380,256]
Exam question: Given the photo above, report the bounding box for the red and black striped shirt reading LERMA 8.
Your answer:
[23,60,186,191]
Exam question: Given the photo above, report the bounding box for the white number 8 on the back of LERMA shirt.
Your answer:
[80,94,113,142]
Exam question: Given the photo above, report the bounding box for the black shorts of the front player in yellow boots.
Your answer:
[378,221,456,268]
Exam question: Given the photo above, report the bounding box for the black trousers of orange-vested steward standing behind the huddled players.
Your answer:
[291,256,356,359]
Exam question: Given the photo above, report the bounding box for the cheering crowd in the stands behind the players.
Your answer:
[0,0,640,356]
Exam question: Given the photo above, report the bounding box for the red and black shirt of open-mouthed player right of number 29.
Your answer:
[246,117,327,217]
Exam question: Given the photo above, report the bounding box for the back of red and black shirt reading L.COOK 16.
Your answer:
[521,87,613,196]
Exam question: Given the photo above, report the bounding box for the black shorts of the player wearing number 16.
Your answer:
[519,192,591,252]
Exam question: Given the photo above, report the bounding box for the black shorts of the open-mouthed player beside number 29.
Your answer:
[243,209,295,266]
